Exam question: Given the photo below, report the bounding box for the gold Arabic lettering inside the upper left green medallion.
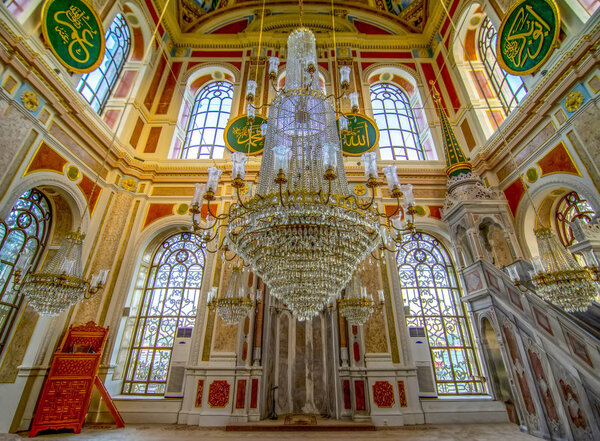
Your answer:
[54,5,98,63]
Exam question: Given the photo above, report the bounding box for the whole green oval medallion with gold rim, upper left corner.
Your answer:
[42,0,104,73]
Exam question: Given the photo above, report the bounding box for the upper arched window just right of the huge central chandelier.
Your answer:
[371,83,425,160]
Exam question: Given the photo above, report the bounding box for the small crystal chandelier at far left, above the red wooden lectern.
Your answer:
[14,232,108,316]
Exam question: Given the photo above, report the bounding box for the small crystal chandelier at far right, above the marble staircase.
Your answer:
[532,228,600,312]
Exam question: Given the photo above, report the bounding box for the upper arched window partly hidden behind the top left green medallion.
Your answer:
[77,14,131,114]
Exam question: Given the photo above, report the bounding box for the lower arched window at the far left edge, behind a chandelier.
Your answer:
[0,189,52,353]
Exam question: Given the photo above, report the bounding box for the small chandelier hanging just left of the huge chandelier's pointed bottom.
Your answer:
[208,266,252,325]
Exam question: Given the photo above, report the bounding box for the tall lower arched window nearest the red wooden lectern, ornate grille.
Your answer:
[123,233,204,395]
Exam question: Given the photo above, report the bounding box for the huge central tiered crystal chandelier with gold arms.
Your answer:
[190,28,414,320]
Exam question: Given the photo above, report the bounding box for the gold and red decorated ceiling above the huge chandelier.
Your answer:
[148,0,450,47]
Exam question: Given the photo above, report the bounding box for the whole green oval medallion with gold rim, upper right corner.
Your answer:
[496,0,560,75]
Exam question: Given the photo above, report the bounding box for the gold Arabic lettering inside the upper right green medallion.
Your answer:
[502,5,552,67]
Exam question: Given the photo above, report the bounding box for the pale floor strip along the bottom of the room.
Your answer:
[0,424,539,441]
